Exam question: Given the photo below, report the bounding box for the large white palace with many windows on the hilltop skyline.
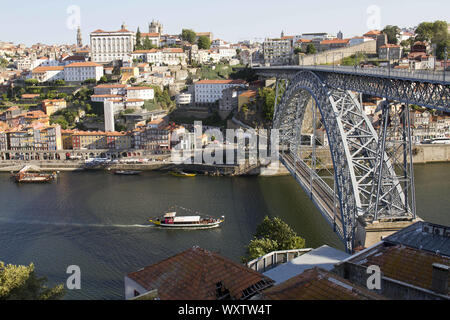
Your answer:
[91,25,136,63]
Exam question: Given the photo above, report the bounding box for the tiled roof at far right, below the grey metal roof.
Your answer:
[361,245,450,293]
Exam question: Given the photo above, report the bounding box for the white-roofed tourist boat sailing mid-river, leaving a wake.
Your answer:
[149,212,225,229]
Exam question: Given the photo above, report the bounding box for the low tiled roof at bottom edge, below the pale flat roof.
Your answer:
[262,267,384,300]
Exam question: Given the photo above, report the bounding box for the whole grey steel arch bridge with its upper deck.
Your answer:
[256,67,450,252]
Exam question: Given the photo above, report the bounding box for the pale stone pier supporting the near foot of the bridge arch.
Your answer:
[363,218,422,248]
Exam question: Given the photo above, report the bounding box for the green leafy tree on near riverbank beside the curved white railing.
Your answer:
[243,217,305,261]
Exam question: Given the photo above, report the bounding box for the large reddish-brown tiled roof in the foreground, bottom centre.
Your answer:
[128,247,273,300]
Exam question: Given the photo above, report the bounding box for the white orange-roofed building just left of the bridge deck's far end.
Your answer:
[194,80,246,103]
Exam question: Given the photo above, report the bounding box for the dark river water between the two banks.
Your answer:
[0,163,450,299]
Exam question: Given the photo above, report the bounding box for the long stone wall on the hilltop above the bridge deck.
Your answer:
[294,41,377,66]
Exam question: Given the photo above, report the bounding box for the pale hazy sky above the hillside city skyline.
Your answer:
[0,0,450,46]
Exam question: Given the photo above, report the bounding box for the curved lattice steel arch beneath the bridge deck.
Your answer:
[273,71,412,252]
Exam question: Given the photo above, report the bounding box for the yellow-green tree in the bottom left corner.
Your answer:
[0,261,65,300]
